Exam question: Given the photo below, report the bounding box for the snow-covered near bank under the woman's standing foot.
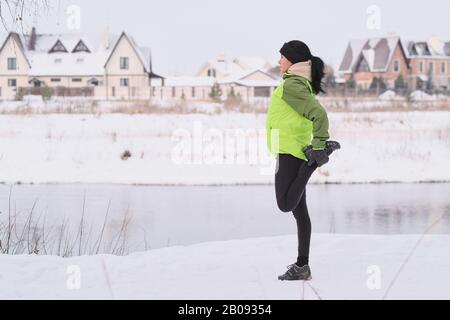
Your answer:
[0,234,450,300]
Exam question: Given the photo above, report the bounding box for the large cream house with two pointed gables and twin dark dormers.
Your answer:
[0,28,162,99]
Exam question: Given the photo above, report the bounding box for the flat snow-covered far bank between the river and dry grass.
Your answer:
[0,111,450,185]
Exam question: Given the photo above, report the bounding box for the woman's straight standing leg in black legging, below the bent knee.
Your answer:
[293,189,311,267]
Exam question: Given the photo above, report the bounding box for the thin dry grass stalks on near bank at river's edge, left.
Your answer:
[0,187,135,257]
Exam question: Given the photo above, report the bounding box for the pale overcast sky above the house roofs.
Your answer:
[2,0,450,75]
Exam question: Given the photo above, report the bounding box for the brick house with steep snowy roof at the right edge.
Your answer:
[338,36,450,90]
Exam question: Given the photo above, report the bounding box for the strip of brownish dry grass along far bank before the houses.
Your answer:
[0,96,450,115]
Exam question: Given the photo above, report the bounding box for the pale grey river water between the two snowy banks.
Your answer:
[0,184,450,250]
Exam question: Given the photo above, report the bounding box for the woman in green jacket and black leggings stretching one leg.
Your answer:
[266,40,340,280]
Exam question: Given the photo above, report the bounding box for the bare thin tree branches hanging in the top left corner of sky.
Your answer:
[0,0,49,34]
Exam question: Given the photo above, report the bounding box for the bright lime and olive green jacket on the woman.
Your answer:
[266,73,330,160]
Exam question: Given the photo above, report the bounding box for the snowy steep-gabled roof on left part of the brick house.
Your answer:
[339,36,401,73]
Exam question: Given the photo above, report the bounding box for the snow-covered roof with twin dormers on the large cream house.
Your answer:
[0,32,155,76]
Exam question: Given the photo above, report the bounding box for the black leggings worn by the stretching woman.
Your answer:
[275,154,317,266]
